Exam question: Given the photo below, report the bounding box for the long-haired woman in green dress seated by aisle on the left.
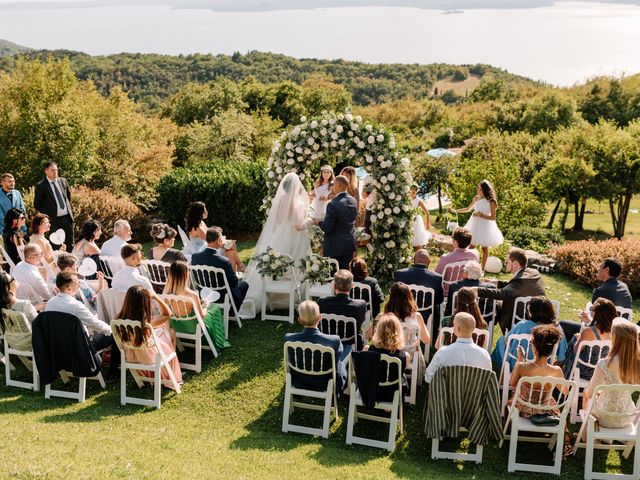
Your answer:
[162,260,231,349]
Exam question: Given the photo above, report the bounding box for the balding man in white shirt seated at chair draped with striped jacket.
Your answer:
[424,312,491,383]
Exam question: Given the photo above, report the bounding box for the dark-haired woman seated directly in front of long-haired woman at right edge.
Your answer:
[564,297,618,380]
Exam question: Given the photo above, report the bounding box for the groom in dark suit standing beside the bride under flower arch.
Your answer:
[315,175,358,269]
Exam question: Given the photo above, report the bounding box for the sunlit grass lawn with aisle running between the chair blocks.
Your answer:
[0,248,640,480]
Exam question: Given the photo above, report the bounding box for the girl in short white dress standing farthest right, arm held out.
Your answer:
[451,180,504,270]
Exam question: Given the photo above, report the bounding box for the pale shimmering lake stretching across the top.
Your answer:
[0,0,640,85]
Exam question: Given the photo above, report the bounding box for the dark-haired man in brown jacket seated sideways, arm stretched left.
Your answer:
[478,248,544,334]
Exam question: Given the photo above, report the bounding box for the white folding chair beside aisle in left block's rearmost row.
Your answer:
[111,320,182,408]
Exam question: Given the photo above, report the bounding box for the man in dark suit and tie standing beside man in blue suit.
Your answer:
[33,162,73,252]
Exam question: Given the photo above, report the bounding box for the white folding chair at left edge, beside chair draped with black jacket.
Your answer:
[0,308,40,392]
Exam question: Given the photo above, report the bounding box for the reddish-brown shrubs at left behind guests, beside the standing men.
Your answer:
[24,186,149,241]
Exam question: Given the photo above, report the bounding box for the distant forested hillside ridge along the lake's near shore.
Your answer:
[0,50,535,111]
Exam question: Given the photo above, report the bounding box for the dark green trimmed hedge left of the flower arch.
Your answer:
[158,160,266,235]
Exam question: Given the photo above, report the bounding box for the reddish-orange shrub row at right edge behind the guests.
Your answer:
[553,239,640,296]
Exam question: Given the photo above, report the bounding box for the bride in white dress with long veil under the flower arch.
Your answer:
[244,172,311,311]
